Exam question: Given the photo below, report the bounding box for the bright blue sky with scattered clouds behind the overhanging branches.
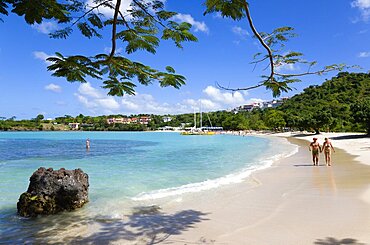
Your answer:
[0,0,370,119]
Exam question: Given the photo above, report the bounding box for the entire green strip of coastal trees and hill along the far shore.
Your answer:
[0,72,370,133]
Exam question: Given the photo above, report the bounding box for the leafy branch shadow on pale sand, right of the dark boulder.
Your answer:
[66,206,207,244]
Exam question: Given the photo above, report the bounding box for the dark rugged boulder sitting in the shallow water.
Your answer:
[17,168,89,217]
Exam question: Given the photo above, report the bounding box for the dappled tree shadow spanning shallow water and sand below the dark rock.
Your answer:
[0,206,208,244]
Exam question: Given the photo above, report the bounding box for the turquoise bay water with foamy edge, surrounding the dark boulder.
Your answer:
[0,132,297,243]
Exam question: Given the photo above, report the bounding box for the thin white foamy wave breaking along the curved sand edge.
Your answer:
[132,138,299,201]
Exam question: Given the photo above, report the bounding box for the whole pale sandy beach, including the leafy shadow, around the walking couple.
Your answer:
[50,133,370,245]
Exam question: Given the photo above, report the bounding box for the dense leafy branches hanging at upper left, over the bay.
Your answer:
[0,0,197,96]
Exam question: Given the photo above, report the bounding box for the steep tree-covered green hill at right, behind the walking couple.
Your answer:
[279,72,370,132]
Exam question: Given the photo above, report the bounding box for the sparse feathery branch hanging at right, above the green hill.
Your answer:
[204,0,350,97]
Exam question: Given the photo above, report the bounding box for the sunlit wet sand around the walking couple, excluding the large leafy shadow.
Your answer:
[152,136,370,244]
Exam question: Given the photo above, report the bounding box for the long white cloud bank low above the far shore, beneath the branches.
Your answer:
[75,83,262,115]
